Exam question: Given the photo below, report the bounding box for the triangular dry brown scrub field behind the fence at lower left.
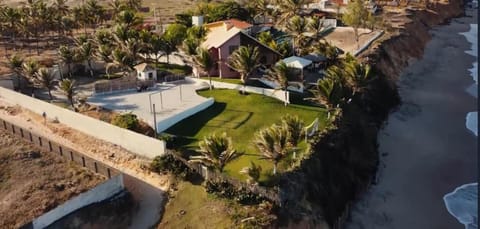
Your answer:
[0,130,105,228]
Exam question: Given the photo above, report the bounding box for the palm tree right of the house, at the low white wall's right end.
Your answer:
[265,60,295,106]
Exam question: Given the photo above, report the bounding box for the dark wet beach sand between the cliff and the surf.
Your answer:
[346,8,478,229]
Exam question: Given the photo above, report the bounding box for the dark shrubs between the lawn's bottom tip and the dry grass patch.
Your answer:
[205,180,265,204]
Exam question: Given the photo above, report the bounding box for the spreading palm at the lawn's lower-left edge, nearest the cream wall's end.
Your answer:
[189,133,242,172]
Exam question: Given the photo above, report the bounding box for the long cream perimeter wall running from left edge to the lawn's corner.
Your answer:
[0,87,166,159]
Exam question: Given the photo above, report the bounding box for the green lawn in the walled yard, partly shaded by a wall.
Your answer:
[165,89,325,180]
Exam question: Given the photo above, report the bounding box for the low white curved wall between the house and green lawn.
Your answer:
[185,77,290,103]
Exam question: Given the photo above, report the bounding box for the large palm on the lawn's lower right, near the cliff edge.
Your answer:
[254,125,291,175]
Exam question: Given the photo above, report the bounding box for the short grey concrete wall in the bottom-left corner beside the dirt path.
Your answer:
[32,174,125,229]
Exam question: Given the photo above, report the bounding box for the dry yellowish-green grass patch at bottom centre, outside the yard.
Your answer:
[158,181,233,228]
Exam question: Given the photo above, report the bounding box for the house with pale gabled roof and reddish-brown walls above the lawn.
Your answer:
[196,19,281,78]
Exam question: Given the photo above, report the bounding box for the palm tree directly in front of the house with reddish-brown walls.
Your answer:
[227,46,260,93]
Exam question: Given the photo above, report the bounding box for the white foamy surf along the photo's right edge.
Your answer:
[443,19,478,229]
